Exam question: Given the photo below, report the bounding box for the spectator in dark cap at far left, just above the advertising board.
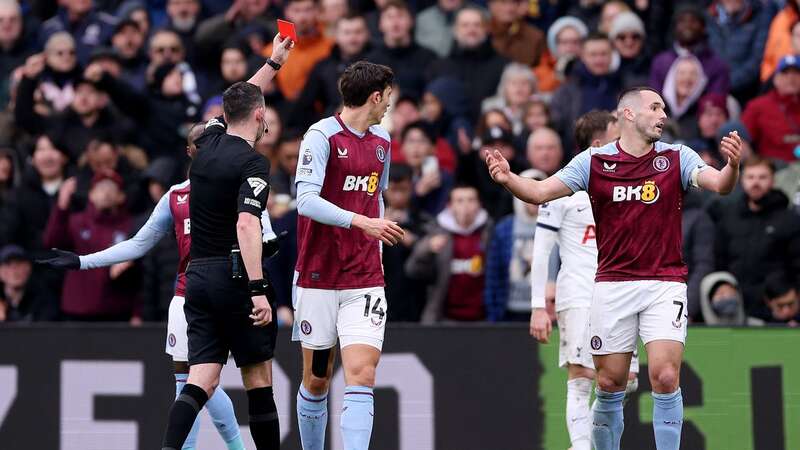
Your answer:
[0,245,58,322]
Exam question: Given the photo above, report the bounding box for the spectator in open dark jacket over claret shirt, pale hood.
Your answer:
[406,186,492,324]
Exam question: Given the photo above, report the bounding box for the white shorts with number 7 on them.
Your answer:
[589,280,689,355]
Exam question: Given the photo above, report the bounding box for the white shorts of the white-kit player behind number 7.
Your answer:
[558,308,639,373]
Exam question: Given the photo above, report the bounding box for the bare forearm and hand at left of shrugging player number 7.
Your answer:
[486,150,572,205]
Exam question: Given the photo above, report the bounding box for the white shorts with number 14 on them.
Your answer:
[292,286,387,350]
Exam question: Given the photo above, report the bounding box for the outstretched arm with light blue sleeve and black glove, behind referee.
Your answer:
[39,188,172,270]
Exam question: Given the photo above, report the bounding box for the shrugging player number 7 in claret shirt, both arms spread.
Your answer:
[486,87,742,450]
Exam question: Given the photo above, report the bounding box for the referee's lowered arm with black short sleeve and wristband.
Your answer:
[236,153,272,327]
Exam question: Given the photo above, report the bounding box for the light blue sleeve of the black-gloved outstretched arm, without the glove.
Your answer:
[80,192,173,270]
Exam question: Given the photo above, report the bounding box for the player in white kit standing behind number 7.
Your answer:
[531,111,639,450]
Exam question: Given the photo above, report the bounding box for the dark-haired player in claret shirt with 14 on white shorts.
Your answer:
[292,61,403,450]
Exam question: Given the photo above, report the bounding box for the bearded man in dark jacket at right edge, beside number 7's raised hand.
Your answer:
[710,156,800,320]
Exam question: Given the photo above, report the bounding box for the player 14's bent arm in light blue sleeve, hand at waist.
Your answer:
[295,129,403,245]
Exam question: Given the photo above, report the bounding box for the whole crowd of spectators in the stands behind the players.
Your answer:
[0,0,800,326]
